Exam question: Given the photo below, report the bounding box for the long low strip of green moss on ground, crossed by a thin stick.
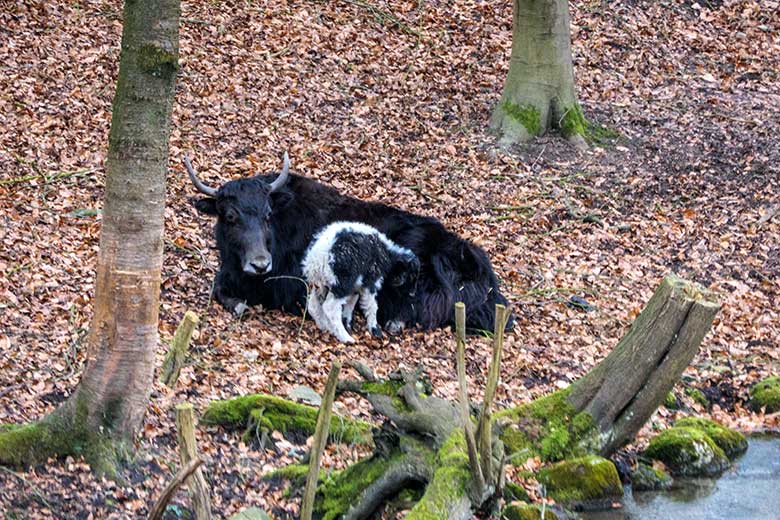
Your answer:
[202,394,371,444]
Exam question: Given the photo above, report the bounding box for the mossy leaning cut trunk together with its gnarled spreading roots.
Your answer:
[304,276,720,520]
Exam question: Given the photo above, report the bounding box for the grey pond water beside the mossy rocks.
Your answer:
[582,438,780,520]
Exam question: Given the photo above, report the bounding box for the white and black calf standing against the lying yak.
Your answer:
[301,222,420,343]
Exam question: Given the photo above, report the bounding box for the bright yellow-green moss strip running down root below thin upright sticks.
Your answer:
[405,429,471,520]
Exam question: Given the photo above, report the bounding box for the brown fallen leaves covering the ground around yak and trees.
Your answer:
[0,0,780,518]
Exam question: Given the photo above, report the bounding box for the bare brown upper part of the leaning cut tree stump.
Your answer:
[568,275,720,456]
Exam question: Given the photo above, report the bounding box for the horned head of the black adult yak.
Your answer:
[184,152,290,275]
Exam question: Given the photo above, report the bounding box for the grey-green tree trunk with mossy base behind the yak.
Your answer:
[490,0,587,146]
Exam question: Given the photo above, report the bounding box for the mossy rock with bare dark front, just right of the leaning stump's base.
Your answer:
[645,426,729,476]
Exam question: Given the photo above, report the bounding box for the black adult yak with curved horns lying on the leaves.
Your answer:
[184,153,512,332]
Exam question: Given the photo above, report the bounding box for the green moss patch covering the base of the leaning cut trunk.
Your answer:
[495,389,597,464]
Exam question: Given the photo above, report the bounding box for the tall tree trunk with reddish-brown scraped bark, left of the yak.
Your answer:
[0,0,180,471]
